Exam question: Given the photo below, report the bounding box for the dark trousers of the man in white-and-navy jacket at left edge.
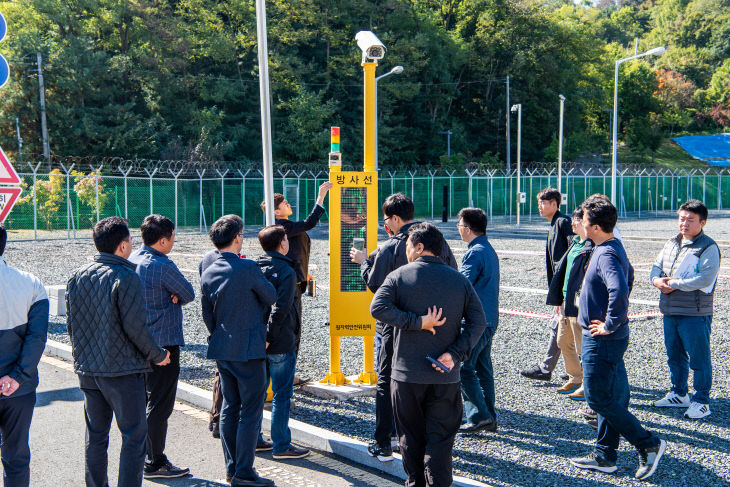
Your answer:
[0,391,35,487]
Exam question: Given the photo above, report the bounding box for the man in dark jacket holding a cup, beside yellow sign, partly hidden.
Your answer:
[350,193,457,461]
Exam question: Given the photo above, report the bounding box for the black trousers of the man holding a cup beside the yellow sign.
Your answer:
[373,325,393,447]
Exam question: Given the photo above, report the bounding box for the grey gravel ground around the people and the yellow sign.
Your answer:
[6,214,730,486]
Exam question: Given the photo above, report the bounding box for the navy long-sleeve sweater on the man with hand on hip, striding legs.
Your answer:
[578,239,634,340]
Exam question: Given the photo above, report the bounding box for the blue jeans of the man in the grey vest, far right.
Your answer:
[664,315,712,404]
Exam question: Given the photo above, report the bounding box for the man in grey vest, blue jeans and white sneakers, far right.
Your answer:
[649,200,720,419]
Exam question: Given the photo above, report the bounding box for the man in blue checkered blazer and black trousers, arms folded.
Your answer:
[129,215,195,479]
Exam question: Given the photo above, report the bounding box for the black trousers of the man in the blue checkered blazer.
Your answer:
[145,345,180,469]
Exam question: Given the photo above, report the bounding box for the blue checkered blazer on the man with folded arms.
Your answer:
[129,245,195,347]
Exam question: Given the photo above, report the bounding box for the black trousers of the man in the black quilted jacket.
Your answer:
[79,374,147,487]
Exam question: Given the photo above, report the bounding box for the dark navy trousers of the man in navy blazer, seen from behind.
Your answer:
[216,359,268,480]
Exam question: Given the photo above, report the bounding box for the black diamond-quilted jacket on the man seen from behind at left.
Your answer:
[66,252,167,377]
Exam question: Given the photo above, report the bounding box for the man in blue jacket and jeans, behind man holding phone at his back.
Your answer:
[456,208,499,433]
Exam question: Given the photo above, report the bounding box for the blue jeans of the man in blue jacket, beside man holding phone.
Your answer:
[461,326,497,424]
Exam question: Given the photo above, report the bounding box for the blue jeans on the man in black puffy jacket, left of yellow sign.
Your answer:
[266,352,297,453]
